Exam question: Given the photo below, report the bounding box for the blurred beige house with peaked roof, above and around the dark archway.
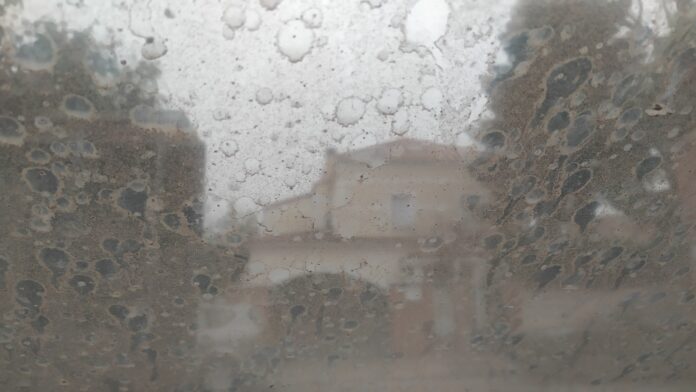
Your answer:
[196,139,489,355]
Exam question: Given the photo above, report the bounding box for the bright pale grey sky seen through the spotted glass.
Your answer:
[6,0,666,236]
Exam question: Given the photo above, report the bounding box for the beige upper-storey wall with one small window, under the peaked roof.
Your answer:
[331,161,482,238]
